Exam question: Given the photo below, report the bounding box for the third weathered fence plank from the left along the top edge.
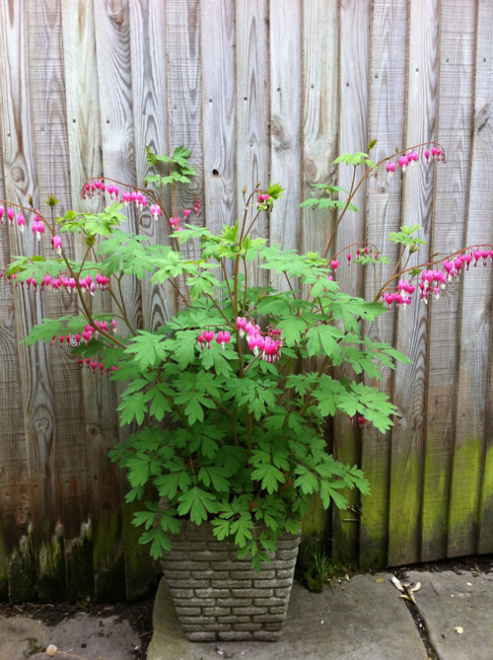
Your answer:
[62,0,118,598]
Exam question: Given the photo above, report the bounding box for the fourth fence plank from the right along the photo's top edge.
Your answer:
[360,0,408,567]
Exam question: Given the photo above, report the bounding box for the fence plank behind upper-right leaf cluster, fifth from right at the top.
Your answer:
[333,0,370,562]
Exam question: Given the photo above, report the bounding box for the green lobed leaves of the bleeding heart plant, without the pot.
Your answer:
[6,145,419,568]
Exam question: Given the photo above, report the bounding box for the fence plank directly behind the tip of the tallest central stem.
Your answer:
[235,0,270,286]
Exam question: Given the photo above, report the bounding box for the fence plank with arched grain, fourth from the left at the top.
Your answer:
[94,0,138,600]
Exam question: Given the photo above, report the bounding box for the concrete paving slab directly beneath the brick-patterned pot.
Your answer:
[147,573,426,660]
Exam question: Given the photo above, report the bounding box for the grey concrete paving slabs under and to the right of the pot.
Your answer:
[147,571,493,660]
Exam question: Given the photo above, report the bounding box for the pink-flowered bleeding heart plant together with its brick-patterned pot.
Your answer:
[0,145,488,639]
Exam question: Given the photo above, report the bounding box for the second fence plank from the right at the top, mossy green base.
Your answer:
[421,0,475,561]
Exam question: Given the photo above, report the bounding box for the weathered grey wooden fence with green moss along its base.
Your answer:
[0,0,493,601]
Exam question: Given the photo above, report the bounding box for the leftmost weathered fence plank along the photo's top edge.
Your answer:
[1,2,57,600]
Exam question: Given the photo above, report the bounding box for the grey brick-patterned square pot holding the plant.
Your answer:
[161,521,300,642]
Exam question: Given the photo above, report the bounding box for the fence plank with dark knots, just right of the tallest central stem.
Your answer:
[269,0,302,258]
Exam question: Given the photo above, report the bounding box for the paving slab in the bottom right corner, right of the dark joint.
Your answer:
[407,571,493,660]
